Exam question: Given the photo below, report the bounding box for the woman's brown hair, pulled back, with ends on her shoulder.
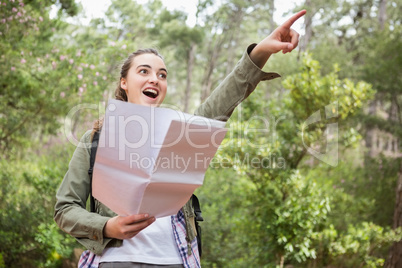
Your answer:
[92,48,163,136]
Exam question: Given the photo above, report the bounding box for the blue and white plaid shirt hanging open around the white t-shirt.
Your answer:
[78,210,201,268]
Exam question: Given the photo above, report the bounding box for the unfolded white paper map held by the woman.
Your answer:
[92,100,227,217]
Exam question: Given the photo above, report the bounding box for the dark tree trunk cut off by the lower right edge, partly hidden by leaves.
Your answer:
[385,165,402,268]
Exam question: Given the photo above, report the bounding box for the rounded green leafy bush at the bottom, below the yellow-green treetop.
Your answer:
[249,172,330,267]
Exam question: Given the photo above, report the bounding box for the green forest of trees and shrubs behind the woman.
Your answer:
[0,0,402,267]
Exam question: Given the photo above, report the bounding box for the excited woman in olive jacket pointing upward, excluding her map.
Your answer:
[54,10,306,268]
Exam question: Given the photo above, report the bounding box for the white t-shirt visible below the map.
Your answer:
[100,216,183,264]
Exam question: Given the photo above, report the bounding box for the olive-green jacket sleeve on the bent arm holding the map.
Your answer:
[54,131,121,255]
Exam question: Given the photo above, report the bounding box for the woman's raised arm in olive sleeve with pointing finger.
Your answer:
[195,10,306,121]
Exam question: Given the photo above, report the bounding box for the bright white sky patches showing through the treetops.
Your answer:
[73,0,303,33]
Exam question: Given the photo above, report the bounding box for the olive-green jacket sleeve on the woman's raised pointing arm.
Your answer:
[195,44,280,121]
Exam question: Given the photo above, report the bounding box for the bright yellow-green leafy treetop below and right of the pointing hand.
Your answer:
[278,55,373,168]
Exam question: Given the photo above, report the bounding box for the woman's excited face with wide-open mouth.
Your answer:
[120,54,167,106]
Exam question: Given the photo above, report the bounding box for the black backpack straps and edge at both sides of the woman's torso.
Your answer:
[88,131,204,258]
